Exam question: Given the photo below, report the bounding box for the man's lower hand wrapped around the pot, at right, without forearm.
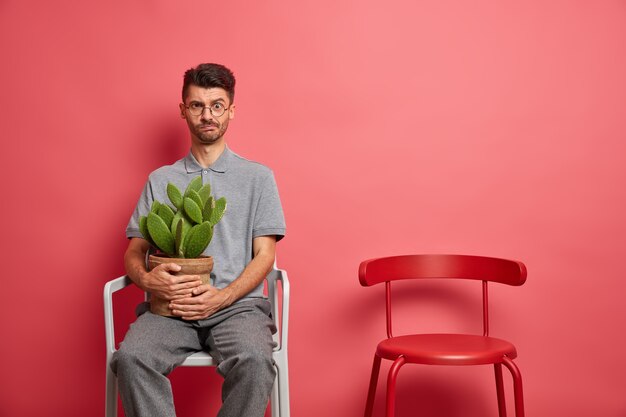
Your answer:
[169,284,232,320]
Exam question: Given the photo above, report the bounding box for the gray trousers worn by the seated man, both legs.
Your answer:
[111,299,276,417]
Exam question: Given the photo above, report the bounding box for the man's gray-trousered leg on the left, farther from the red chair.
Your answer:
[111,312,202,417]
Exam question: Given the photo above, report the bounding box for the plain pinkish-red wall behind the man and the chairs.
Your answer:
[0,0,626,417]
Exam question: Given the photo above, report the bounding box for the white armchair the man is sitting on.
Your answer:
[104,268,289,417]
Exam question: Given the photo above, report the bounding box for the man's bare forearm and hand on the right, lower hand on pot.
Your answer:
[170,236,276,320]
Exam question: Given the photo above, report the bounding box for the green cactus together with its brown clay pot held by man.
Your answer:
[139,176,226,316]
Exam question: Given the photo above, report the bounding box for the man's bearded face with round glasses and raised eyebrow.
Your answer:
[179,85,235,145]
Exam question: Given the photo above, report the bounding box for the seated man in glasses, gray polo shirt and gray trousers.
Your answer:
[111,64,285,417]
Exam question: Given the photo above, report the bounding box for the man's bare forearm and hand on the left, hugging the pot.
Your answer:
[124,238,202,300]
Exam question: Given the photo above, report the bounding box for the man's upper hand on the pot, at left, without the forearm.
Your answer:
[141,263,202,301]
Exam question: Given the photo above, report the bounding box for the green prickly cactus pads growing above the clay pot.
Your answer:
[139,176,226,258]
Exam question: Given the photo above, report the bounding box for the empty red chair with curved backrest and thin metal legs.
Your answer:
[359,255,526,417]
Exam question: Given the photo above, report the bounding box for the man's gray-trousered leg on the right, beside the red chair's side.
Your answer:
[207,300,276,417]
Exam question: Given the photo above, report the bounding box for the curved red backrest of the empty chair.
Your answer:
[359,255,526,287]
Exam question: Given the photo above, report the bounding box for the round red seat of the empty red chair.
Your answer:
[376,334,517,365]
